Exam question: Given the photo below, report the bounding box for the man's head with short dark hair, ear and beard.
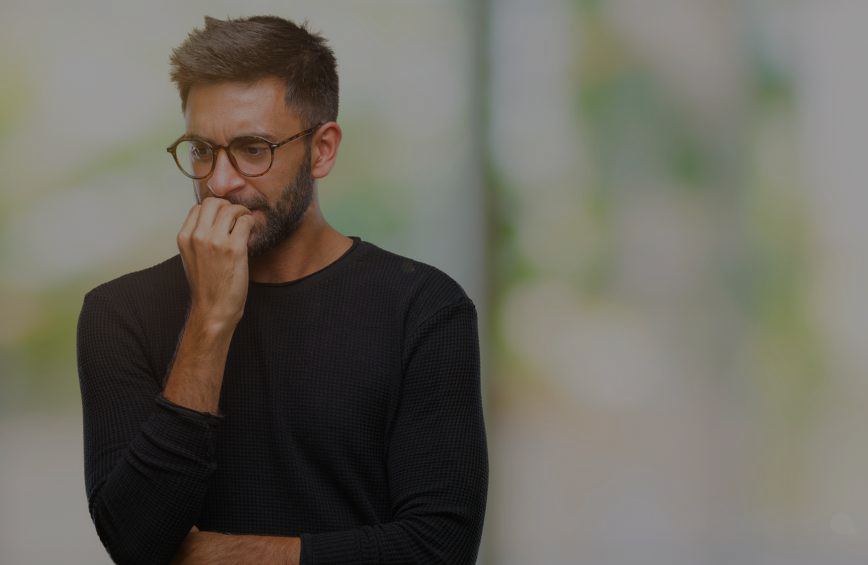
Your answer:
[171,16,341,256]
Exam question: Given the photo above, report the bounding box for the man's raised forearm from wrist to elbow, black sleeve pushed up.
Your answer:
[90,313,234,561]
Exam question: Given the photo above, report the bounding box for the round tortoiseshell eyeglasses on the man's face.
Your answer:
[166,122,324,180]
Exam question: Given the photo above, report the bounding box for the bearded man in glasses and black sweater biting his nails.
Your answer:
[78,17,488,565]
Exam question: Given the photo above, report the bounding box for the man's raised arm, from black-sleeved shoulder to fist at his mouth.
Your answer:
[77,198,251,563]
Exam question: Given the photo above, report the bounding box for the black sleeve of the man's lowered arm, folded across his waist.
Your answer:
[301,297,488,565]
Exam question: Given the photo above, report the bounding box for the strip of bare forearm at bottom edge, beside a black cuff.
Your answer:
[171,526,301,565]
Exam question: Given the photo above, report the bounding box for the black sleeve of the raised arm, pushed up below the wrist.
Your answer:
[77,291,222,563]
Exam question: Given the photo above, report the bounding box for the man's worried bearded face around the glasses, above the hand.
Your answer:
[184,78,314,257]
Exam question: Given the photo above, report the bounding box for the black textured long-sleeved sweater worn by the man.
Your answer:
[77,237,488,565]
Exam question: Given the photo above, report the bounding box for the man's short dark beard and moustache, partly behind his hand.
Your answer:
[228,147,313,257]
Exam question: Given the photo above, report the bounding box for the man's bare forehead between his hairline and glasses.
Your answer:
[184,78,299,139]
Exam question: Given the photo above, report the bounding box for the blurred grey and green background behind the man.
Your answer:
[0,0,868,565]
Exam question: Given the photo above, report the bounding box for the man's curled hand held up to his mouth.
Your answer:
[177,197,253,327]
